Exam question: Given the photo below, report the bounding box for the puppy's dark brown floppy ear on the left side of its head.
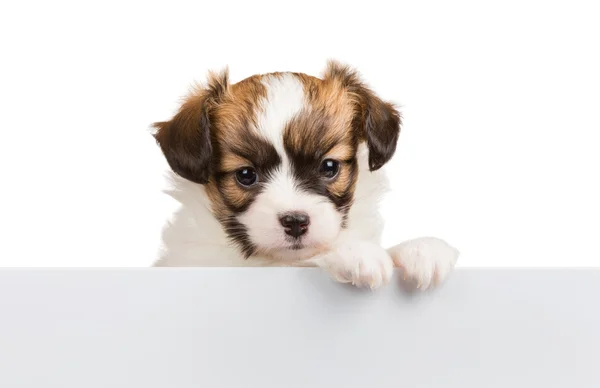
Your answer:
[153,69,229,184]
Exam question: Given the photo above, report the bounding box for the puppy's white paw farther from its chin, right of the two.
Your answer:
[388,237,459,290]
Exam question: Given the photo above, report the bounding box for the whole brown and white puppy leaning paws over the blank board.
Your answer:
[153,61,458,289]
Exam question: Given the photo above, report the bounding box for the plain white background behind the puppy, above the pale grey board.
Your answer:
[0,0,600,266]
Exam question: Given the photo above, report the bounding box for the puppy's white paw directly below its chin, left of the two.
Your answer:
[318,241,394,290]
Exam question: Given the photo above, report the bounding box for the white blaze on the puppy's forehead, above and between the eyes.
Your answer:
[256,74,306,159]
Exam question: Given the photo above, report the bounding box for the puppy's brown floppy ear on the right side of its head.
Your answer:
[323,60,402,171]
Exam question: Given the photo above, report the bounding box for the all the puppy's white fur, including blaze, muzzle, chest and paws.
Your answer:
[156,75,458,289]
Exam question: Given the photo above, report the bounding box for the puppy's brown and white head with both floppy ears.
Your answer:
[155,62,400,260]
